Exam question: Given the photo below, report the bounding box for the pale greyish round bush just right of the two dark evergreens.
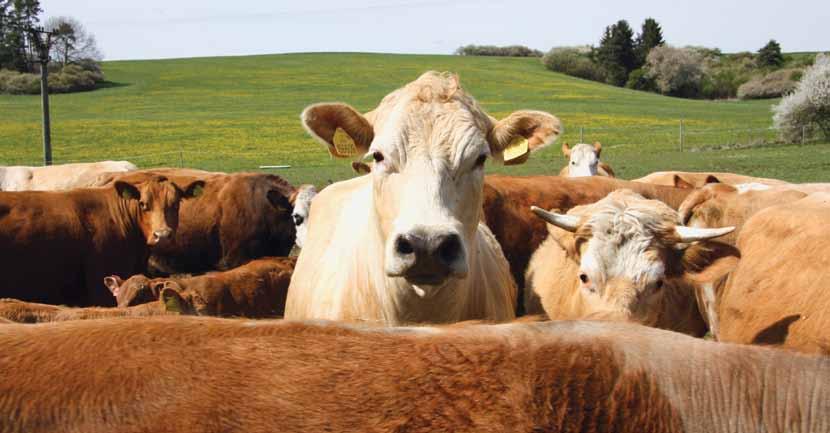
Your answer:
[646,46,704,98]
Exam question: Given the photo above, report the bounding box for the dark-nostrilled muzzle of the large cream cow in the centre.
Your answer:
[386,230,468,286]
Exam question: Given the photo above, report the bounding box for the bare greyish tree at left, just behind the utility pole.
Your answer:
[46,17,103,66]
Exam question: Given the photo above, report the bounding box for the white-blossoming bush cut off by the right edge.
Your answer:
[772,54,830,142]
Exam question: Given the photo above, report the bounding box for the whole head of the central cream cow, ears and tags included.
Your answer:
[302,72,561,296]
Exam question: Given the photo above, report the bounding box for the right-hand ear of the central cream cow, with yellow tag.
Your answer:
[487,110,562,165]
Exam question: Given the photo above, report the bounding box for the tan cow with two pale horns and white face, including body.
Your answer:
[525,189,736,336]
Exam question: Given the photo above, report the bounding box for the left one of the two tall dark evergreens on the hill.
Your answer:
[597,20,637,86]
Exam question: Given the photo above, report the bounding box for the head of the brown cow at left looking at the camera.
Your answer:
[114,176,205,246]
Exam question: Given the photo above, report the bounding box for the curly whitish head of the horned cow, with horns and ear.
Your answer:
[532,190,734,325]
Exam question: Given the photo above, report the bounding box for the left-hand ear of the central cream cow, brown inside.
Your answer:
[300,103,375,158]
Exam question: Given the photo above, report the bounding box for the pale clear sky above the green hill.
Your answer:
[41,0,830,60]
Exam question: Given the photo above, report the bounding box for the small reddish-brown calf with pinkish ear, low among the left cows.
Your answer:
[104,257,297,318]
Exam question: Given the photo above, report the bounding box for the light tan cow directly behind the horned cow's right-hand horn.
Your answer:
[678,183,807,246]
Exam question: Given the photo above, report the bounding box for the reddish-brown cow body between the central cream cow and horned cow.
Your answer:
[483,175,691,314]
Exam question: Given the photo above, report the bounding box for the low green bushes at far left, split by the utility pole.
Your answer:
[0,64,104,95]
